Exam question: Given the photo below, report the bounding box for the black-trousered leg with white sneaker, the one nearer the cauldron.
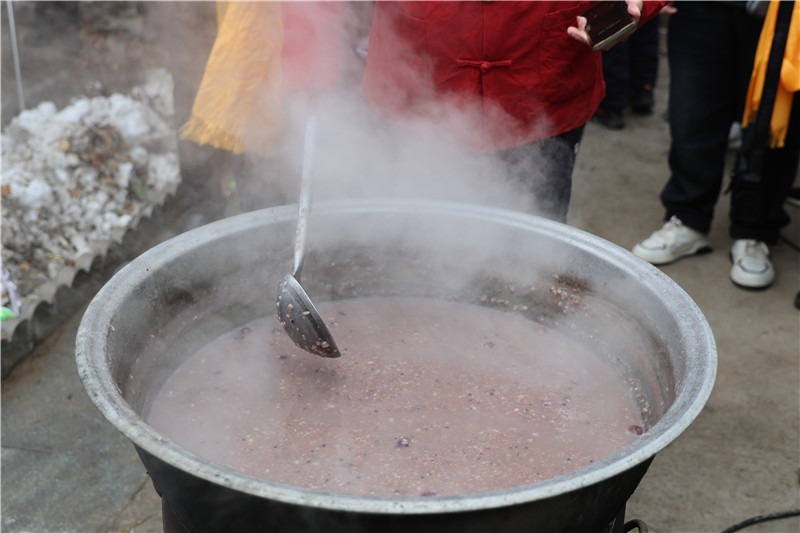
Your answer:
[633,2,760,264]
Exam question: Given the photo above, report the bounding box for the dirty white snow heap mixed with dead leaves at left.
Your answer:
[0,70,180,332]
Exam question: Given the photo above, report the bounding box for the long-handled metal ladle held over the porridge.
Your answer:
[276,115,342,357]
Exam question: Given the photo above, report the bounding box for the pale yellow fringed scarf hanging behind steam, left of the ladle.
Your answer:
[180,2,283,157]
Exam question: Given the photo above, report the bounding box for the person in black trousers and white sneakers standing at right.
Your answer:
[632,2,800,289]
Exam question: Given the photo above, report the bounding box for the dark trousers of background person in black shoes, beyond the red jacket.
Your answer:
[600,17,660,111]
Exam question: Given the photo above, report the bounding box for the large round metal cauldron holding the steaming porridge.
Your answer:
[77,200,716,533]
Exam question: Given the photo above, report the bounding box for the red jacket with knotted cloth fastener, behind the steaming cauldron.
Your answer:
[362,1,666,151]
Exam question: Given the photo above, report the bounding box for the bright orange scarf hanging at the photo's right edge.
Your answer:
[742,0,800,148]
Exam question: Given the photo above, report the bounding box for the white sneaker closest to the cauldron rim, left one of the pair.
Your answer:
[633,216,711,265]
